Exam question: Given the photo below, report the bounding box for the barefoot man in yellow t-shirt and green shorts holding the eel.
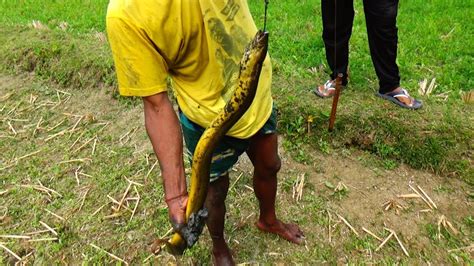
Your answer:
[107,0,303,265]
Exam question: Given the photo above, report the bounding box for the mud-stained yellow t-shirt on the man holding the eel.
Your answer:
[107,0,272,139]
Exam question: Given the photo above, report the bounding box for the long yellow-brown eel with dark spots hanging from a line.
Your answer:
[166,30,268,254]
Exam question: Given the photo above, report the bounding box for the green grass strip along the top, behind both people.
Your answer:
[0,0,474,180]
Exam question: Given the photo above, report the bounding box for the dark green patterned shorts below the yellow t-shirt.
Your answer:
[179,108,277,182]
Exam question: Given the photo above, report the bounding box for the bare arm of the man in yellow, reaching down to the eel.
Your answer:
[143,92,188,226]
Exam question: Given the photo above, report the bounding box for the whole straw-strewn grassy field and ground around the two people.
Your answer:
[0,0,474,264]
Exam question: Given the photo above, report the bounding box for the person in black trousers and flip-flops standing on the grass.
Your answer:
[313,0,423,109]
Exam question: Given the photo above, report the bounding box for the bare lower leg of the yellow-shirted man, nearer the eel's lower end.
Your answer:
[205,174,234,265]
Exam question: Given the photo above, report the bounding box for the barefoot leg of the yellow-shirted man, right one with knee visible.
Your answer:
[247,133,304,244]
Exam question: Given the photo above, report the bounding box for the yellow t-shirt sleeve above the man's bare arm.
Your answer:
[107,17,168,97]
